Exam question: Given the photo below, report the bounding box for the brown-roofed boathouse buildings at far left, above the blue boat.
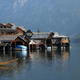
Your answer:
[0,23,29,50]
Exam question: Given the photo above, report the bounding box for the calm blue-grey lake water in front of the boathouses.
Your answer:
[0,45,80,80]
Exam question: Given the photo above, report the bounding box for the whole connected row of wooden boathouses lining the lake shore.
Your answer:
[0,23,70,51]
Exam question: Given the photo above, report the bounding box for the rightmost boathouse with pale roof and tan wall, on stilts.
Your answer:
[52,33,70,49]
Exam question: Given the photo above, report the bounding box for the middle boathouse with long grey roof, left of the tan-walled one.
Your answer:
[29,32,54,50]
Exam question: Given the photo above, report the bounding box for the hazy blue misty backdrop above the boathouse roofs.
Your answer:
[0,0,80,36]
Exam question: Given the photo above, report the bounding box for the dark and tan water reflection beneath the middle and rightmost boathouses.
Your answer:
[30,49,70,60]
